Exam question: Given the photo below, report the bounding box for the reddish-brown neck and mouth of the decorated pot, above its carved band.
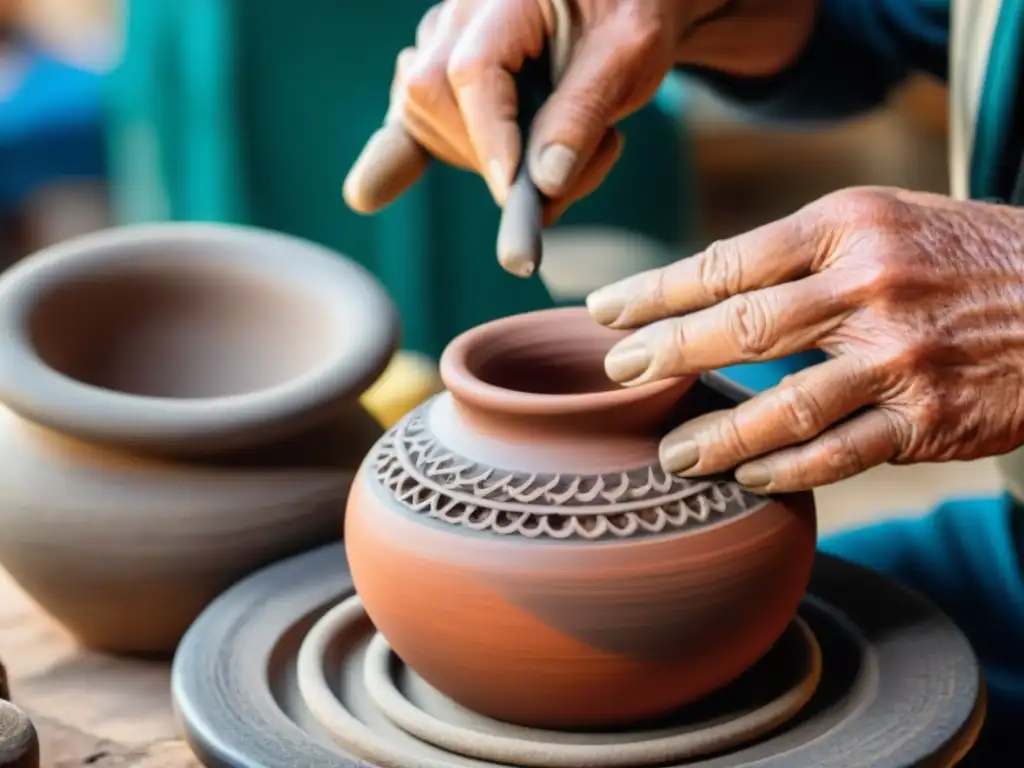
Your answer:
[436,307,694,468]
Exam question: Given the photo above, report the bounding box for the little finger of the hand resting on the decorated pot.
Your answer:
[736,408,898,494]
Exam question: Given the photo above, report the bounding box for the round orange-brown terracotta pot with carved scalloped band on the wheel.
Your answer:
[345,309,816,728]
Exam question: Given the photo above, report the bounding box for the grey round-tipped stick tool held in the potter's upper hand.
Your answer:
[498,50,552,278]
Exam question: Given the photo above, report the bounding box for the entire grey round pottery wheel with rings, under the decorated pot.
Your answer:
[173,545,984,768]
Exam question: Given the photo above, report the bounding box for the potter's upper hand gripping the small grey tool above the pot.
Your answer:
[346,0,818,222]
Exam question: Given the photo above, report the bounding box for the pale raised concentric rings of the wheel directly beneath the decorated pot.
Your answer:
[297,597,822,768]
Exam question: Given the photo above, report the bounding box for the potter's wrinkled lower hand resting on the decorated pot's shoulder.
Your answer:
[588,188,1024,492]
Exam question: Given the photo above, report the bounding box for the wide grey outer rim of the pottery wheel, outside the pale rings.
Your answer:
[172,544,983,768]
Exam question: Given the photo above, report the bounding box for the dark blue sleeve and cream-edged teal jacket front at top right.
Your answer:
[691,0,1024,200]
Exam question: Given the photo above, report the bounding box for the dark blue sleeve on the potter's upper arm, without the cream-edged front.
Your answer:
[681,0,949,121]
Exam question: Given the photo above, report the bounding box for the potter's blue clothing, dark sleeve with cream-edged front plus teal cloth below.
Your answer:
[689,0,1024,768]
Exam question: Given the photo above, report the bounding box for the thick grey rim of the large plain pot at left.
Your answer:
[0,223,398,449]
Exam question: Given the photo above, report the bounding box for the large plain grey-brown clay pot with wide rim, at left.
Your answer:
[0,224,396,653]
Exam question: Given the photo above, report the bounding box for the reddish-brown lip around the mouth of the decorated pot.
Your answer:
[440,307,684,416]
